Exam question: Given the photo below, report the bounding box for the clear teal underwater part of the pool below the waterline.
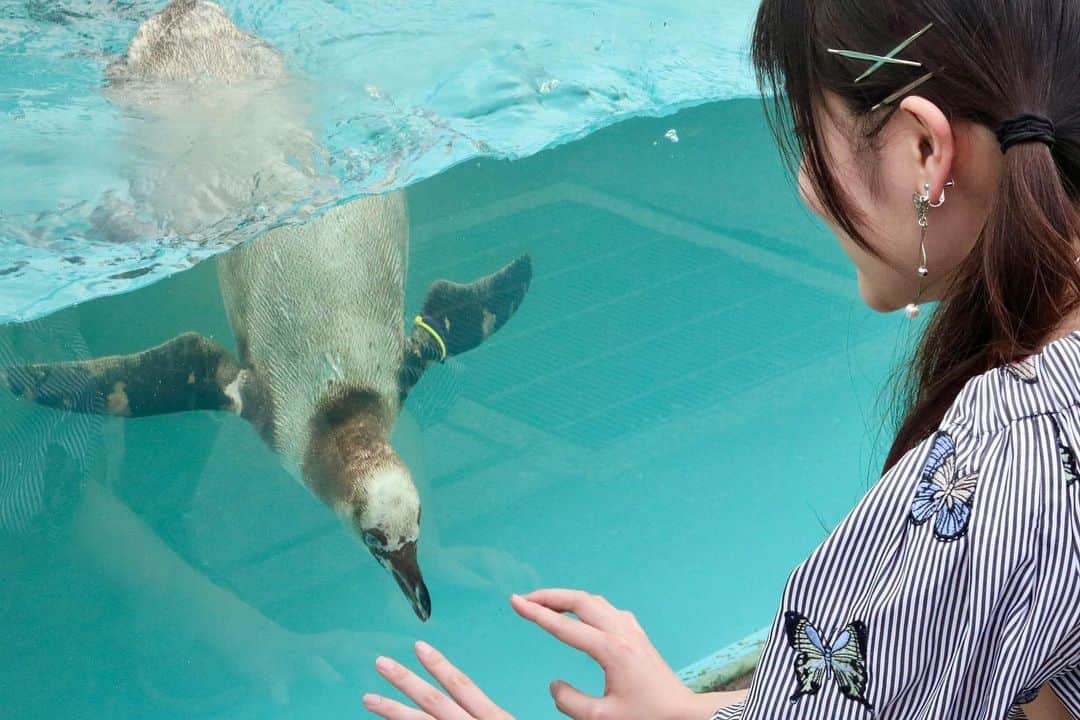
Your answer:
[0,100,910,719]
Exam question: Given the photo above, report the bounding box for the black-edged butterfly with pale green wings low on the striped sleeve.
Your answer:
[784,611,874,714]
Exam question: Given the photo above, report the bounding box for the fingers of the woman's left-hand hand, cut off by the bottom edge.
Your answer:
[364,642,513,720]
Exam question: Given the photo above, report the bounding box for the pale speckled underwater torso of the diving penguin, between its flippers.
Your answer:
[218,192,408,466]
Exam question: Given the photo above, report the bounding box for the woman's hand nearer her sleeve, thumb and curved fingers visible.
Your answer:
[511,589,699,720]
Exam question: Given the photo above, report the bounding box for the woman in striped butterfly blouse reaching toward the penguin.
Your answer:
[365,0,1080,720]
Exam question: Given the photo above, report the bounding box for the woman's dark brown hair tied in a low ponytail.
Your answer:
[753,0,1080,468]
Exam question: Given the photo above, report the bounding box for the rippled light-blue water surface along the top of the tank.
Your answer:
[0,0,757,322]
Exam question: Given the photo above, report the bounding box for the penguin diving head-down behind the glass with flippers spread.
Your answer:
[0,0,532,620]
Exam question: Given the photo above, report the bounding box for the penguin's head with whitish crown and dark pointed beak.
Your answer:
[352,464,431,621]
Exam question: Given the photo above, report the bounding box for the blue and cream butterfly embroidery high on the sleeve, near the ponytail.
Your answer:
[910,432,976,541]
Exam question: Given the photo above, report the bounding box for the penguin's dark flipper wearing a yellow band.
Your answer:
[399,255,532,400]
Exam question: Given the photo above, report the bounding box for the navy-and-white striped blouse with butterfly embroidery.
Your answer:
[714,332,1080,720]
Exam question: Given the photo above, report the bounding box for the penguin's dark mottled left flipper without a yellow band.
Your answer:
[0,332,245,418]
